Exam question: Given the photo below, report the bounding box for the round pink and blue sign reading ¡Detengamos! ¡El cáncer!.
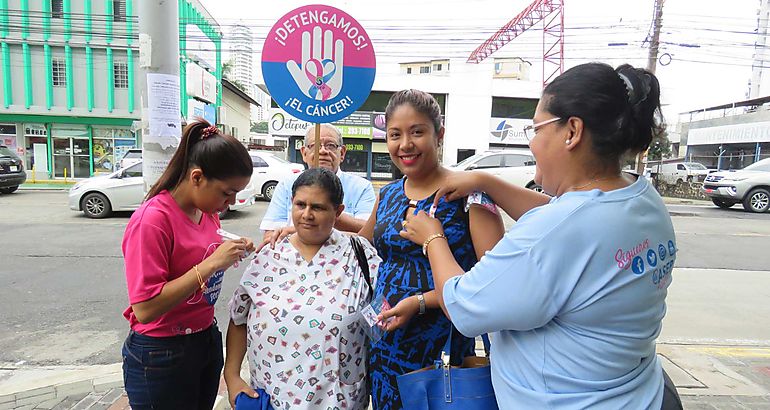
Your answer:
[262,4,377,123]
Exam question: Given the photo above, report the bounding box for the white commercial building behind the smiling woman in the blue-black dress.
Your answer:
[270,58,542,179]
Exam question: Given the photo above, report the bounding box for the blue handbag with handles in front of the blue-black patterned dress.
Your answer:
[396,328,498,410]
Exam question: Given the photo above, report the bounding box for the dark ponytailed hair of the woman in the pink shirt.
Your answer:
[145,119,252,199]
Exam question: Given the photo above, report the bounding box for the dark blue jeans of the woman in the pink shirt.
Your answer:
[123,323,224,410]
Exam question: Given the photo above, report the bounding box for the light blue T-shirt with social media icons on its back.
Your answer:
[443,178,676,410]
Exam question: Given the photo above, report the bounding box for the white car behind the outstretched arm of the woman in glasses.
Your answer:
[450,149,543,192]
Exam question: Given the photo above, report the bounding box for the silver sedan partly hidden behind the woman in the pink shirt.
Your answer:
[69,160,257,219]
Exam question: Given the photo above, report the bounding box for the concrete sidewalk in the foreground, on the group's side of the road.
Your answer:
[0,343,770,410]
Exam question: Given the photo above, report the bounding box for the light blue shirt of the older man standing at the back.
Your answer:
[259,170,375,231]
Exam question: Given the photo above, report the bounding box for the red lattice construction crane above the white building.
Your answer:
[468,0,564,87]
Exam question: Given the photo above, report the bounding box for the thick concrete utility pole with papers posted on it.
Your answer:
[136,0,182,192]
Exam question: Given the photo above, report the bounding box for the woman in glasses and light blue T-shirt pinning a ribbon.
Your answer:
[392,63,681,409]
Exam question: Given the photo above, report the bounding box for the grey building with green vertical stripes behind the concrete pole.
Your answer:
[0,0,222,179]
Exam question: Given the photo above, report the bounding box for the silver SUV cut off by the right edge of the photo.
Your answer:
[701,158,770,212]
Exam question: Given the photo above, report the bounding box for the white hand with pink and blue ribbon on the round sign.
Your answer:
[286,27,344,101]
